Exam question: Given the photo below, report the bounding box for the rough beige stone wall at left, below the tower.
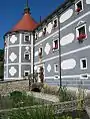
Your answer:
[0,80,29,95]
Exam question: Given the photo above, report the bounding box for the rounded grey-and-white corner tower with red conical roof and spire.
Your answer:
[4,0,38,80]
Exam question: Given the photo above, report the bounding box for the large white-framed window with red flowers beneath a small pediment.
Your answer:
[76,24,87,41]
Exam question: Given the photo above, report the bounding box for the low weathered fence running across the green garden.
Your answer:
[0,100,85,114]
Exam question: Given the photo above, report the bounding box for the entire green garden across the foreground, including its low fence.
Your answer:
[0,90,89,119]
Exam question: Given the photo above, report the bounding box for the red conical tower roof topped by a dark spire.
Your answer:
[11,2,38,32]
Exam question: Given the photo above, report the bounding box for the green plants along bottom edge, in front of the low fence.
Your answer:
[0,105,90,119]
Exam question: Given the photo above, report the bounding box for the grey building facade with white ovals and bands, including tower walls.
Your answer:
[4,0,90,89]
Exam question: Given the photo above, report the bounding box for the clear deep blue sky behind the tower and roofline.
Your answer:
[0,0,64,48]
